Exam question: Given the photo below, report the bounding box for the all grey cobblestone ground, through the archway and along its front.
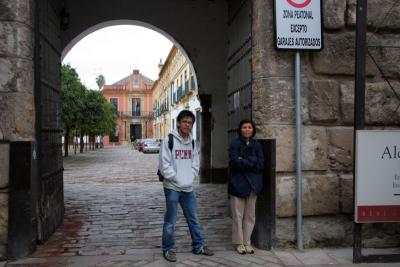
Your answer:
[0,146,398,267]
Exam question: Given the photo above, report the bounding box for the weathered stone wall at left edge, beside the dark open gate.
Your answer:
[0,0,35,259]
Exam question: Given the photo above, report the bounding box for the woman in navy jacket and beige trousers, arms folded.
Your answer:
[228,120,264,254]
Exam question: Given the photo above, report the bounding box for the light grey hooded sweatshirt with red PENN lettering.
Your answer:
[158,130,200,192]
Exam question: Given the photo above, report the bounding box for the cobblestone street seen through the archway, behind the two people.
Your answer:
[40,147,230,256]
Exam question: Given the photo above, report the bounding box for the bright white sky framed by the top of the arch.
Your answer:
[62,25,173,89]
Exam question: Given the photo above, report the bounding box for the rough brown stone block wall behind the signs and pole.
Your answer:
[252,0,400,247]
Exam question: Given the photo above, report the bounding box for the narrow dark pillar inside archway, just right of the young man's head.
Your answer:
[199,94,212,183]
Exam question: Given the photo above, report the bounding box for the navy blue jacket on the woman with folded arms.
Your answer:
[228,137,264,198]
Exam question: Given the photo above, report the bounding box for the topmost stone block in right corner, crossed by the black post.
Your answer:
[347,0,400,31]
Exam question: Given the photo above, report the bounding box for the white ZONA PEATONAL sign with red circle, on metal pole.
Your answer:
[274,0,323,50]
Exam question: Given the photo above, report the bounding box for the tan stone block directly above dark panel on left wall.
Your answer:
[0,93,35,141]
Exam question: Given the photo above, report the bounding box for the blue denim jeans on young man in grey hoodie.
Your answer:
[162,188,204,252]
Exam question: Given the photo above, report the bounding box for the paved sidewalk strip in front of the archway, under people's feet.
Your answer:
[0,248,400,267]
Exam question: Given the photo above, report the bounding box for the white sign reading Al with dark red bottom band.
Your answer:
[354,130,400,223]
